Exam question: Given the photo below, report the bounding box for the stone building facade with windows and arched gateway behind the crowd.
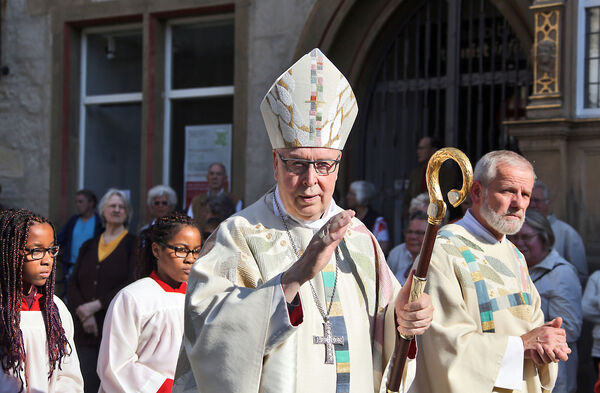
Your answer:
[0,0,600,270]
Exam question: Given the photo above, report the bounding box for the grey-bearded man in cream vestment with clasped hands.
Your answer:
[409,151,570,393]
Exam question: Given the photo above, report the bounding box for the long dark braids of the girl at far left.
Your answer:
[0,209,71,391]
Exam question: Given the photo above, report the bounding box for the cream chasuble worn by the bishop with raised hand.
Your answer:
[173,193,415,393]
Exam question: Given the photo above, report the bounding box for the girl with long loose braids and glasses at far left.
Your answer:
[0,209,83,393]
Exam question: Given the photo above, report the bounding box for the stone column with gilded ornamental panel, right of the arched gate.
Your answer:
[504,0,600,271]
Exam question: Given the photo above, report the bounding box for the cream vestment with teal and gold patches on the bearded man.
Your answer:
[409,224,557,393]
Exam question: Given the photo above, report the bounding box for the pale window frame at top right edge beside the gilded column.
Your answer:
[575,0,600,118]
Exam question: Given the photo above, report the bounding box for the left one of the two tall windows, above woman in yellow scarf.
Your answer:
[78,25,142,228]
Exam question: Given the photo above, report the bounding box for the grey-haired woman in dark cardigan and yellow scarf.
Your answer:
[67,188,136,392]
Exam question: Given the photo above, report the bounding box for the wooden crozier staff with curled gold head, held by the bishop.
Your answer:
[387,147,473,393]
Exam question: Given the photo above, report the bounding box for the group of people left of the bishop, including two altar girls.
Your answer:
[0,158,241,392]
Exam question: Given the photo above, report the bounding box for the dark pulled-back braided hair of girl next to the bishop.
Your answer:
[135,212,200,280]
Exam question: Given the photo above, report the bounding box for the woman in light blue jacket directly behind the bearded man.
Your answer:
[509,210,582,393]
